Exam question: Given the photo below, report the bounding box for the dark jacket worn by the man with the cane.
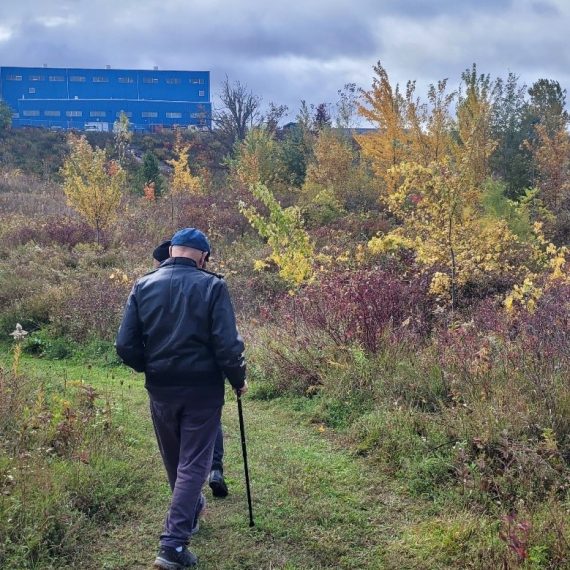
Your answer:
[116,257,245,406]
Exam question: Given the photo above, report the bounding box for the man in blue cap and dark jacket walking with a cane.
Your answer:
[116,228,247,570]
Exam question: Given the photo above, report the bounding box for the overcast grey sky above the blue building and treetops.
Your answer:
[0,0,570,122]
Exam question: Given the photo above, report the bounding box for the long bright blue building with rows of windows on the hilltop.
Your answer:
[0,67,212,131]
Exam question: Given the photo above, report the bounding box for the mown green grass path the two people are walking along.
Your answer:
[18,361,426,570]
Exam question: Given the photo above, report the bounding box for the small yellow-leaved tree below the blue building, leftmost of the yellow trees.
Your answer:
[62,135,125,243]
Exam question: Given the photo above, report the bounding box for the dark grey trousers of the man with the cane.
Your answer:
[150,398,222,548]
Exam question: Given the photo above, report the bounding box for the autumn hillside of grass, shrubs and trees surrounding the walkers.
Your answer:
[0,63,570,569]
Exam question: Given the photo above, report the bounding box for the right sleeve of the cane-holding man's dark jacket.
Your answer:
[210,279,246,390]
